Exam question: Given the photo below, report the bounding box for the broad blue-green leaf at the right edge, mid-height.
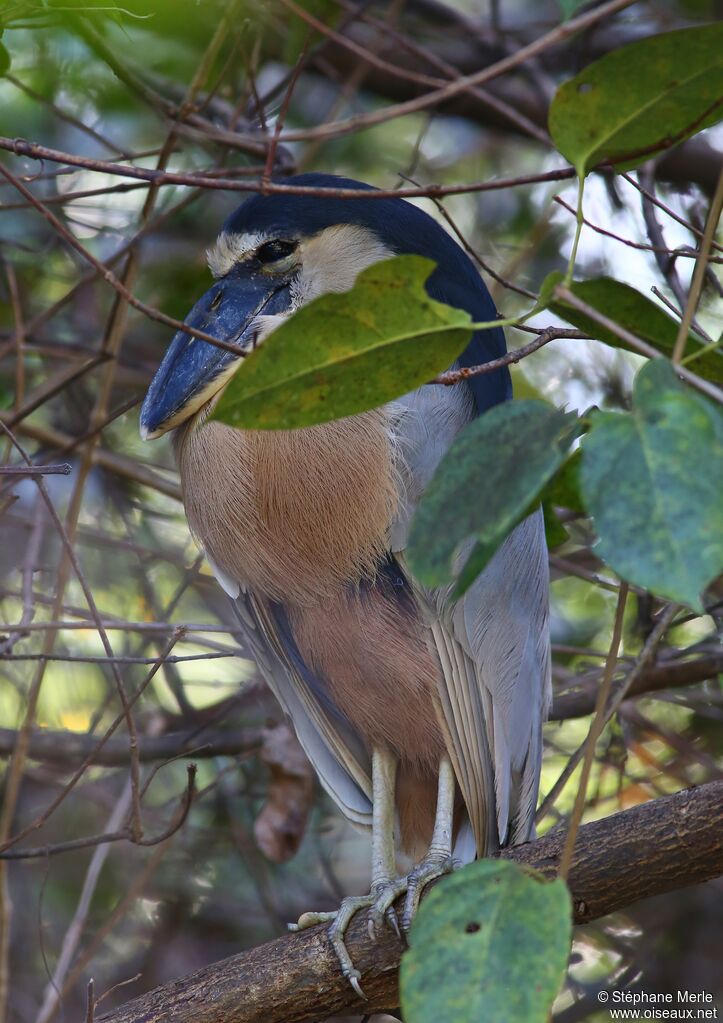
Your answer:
[580,359,723,610]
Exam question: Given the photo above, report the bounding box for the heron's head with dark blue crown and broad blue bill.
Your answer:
[140,174,507,439]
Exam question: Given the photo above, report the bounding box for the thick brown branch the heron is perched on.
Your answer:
[97,782,723,1023]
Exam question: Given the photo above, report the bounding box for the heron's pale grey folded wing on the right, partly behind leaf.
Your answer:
[394,387,550,855]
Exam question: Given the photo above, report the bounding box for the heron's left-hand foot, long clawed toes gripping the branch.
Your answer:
[288,878,407,1000]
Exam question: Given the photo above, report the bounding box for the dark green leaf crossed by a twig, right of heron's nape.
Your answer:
[543,274,723,384]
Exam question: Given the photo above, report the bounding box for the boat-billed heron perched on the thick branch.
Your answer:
[141,174,550,990]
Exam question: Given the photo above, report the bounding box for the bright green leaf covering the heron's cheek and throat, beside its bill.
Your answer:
[214,256,471,430]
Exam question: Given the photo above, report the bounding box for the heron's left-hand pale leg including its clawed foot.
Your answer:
[289,749,399,998]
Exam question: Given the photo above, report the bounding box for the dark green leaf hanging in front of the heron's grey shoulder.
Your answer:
[407,399,580,595]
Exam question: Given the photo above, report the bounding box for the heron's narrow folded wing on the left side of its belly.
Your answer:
[226,585,371,827]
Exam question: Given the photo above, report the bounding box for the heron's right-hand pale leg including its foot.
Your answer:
[369,757,455,932]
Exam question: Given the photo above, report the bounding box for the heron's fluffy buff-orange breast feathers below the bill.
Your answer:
[176,410,399,604]
